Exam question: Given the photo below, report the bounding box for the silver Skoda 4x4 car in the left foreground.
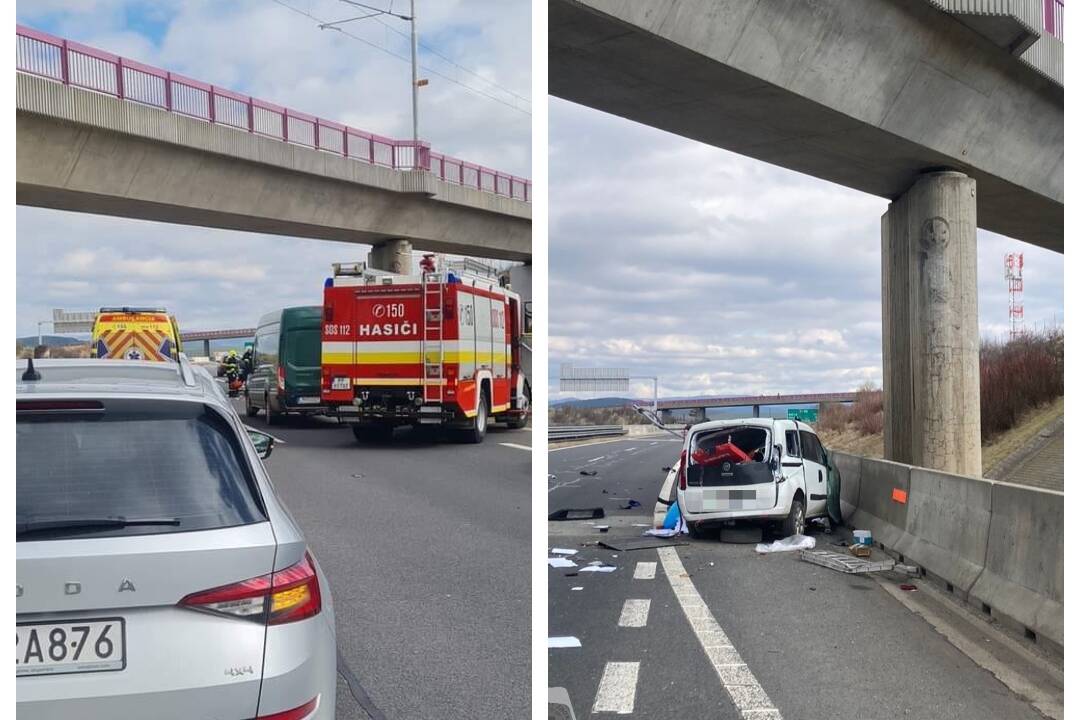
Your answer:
[15,359,337,720]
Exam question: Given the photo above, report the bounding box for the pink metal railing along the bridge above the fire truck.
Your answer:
[15,25,532,202]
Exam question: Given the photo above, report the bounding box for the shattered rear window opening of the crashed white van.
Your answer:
[686,425,773,486]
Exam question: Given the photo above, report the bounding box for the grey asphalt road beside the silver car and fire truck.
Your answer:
[240,408,531,720]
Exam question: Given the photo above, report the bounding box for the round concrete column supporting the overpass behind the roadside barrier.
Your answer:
[881,172,983,477]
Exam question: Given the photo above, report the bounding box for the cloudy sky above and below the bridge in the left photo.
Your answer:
[16,0,531,336]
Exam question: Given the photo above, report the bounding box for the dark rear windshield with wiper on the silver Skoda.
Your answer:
[15,400,265,540]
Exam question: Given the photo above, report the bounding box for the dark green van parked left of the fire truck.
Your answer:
[244,305,326,424]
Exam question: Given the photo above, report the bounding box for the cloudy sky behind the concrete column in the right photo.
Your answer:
[549,98,1064,399]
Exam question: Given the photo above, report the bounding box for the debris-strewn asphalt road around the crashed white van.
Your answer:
[548,439,1041,720]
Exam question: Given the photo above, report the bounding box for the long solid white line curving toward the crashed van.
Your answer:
[658,547,783,720]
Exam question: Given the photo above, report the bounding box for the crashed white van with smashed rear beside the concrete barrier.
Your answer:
[678,418,828,536]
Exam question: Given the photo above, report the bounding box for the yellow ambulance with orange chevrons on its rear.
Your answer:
[91,308,181,363]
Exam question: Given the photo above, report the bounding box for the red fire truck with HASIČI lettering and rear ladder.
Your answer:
[322,256,530,443]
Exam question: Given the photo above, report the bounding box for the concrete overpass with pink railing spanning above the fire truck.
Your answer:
[15,26,531,264]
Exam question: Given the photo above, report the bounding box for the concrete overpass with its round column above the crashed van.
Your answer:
[549,0,1065,475]
